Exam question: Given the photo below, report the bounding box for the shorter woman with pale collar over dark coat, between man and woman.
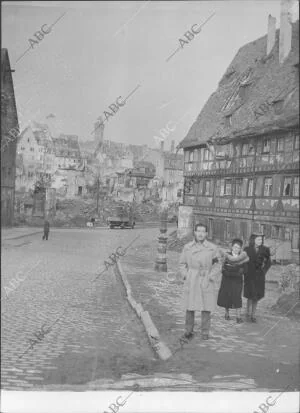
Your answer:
[217,238,249,323]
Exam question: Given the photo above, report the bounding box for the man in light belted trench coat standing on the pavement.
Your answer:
[179,224,221,340]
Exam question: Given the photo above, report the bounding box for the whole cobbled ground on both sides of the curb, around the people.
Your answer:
[1,228,300,391]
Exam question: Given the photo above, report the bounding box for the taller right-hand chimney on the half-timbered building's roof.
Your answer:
[279,0,294,64]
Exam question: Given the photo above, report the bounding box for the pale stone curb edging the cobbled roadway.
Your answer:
[116,261,172,361]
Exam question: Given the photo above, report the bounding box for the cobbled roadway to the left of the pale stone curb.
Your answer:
[1,230,154,390]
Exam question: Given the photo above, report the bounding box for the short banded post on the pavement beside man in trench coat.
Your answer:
[154,187,168,272]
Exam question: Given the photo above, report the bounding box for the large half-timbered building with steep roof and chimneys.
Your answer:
[179,15,299,259]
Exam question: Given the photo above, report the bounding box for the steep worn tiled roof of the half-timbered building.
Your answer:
[179,21,299,148]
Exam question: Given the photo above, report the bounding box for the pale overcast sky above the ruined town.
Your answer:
[2,0,296,148]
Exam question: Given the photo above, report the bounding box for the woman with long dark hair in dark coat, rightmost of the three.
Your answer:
[244,234,271,323]
